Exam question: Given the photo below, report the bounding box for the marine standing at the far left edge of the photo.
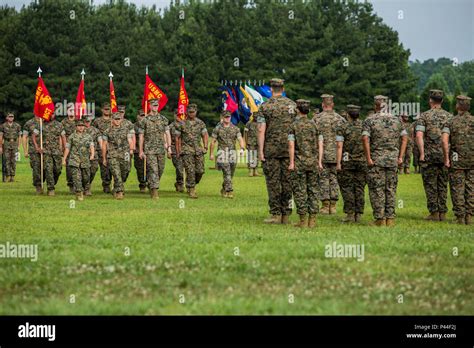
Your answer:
[0,112,21,182]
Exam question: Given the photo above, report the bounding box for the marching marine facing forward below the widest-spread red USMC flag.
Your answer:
[138,99,171,199]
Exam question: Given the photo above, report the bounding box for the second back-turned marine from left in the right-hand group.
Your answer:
[288,99,324,228]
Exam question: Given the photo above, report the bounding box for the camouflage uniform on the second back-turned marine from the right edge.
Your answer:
[415,102,453,214]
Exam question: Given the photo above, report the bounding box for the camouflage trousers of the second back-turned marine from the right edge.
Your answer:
[420,162,448,213]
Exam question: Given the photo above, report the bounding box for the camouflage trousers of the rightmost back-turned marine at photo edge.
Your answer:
[449,168,474,217]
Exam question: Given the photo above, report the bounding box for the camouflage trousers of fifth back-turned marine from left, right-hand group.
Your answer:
[367,166,398,220]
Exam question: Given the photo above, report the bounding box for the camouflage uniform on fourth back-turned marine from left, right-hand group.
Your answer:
[336,109,367,219]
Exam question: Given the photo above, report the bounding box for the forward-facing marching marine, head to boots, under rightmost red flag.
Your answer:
[173,104,209,198]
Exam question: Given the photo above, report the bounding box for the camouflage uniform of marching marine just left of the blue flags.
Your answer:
[212,123,242,192]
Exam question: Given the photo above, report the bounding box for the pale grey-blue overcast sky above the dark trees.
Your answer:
[0,0,474,62]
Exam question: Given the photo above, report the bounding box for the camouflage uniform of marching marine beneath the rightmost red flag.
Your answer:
[175,118,207,189]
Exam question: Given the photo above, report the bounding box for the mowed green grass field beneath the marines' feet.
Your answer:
[0,150,474,315]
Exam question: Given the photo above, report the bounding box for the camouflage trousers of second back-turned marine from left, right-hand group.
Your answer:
[290,170,319,215]
